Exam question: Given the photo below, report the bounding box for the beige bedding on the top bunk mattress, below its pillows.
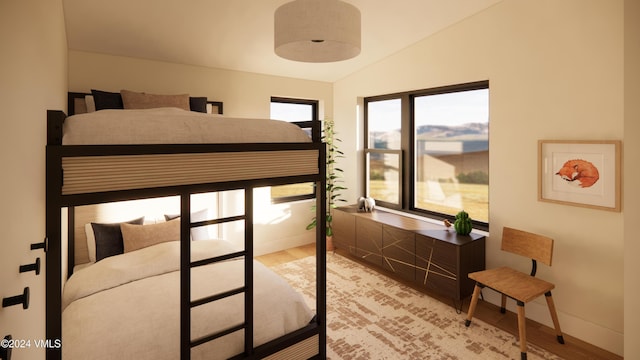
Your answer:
[62,108,311,145]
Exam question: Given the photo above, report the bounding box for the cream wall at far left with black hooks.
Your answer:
[0,0,67,359]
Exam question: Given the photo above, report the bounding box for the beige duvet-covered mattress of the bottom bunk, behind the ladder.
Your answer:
[62,240,314,360]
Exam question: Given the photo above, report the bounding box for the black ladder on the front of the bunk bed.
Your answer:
[180,187,253,360]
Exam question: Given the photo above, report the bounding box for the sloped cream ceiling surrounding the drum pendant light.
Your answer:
[63,0,501,82]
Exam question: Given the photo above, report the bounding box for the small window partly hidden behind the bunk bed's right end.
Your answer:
[271,97,320,203]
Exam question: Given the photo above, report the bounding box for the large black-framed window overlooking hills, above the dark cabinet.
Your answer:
[364,81,489,228]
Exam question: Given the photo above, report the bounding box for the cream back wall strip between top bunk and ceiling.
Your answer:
[69,50,333,118]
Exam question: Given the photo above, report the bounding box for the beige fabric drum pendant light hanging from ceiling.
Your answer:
[274,0,360,63]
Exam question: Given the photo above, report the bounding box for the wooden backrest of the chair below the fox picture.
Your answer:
[502,227,553,266]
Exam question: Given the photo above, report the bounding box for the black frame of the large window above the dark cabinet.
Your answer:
[362,80,489,231]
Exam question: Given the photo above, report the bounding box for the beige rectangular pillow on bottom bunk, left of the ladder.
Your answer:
[120,219,180,253]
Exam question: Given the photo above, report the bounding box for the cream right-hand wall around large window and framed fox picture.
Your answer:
[334,0,624,354]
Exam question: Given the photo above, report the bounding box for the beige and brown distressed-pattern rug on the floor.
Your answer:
[273,253,562,360]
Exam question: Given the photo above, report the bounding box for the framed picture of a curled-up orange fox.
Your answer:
[538,140,622,211]
